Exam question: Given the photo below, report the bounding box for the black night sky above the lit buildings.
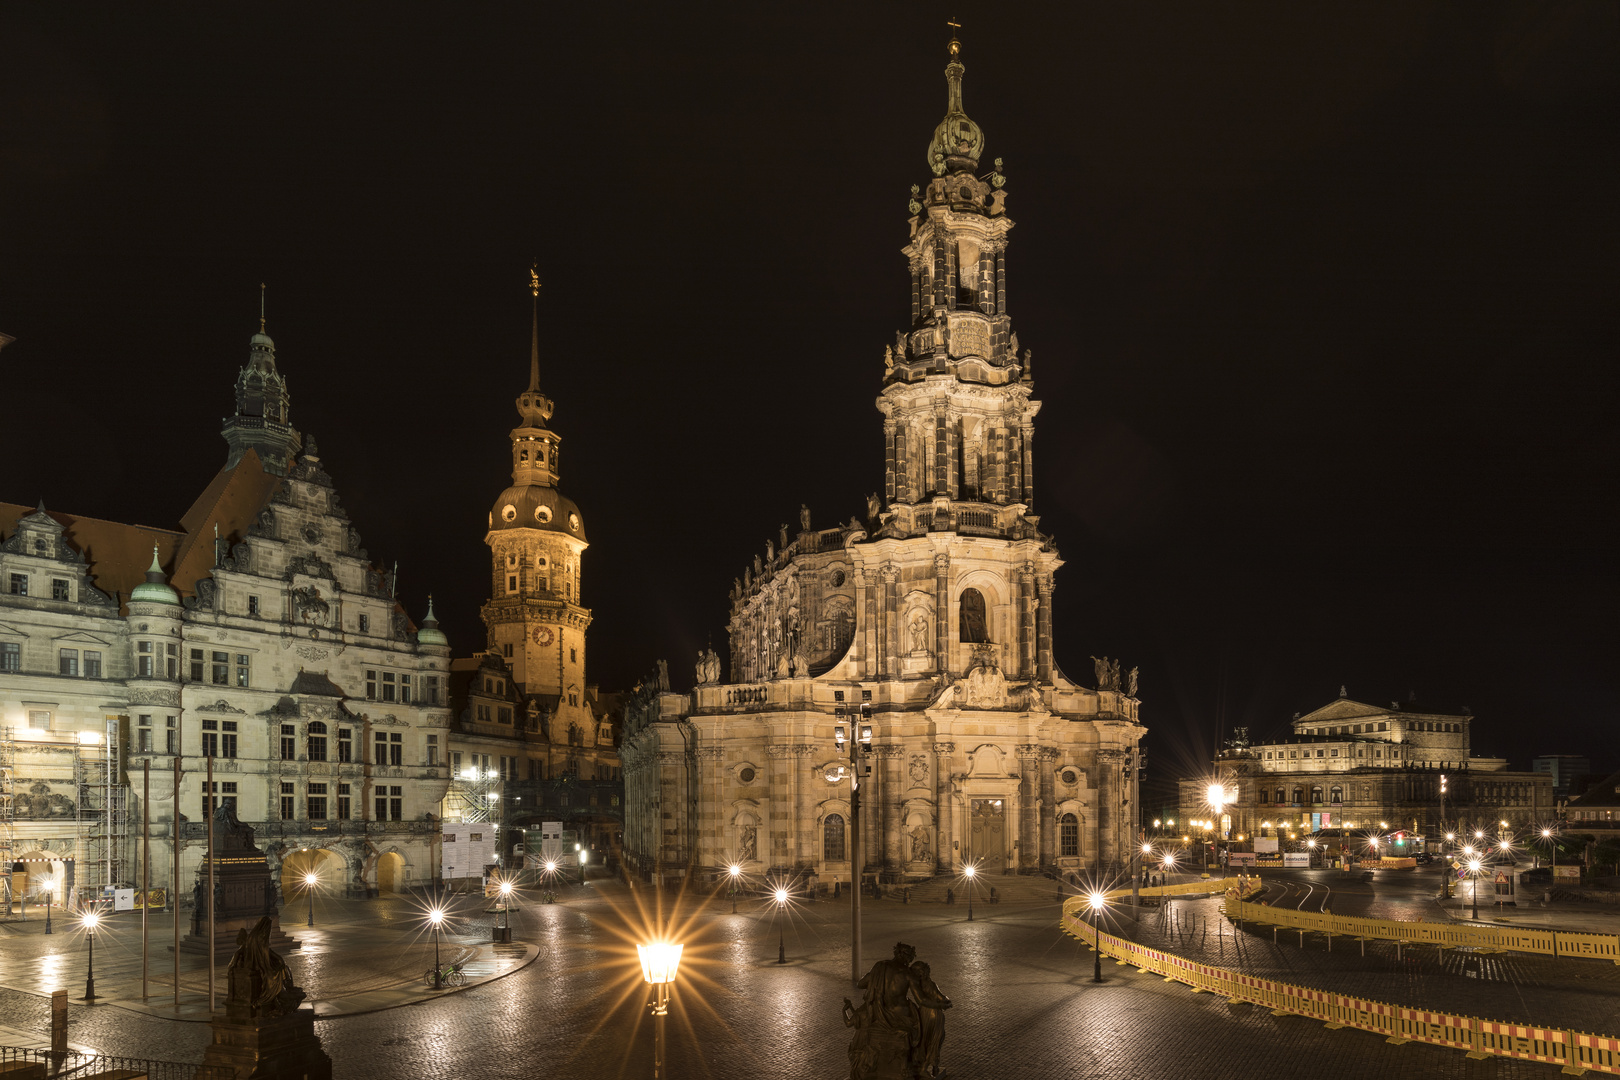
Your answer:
[0,0,1620,786]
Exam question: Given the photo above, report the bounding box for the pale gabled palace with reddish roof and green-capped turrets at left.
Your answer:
[0,321,450,904]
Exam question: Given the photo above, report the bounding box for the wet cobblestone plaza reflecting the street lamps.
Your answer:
[0,871,1620,1078]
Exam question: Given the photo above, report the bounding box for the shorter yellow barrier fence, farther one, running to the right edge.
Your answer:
[1225,895,1620,963]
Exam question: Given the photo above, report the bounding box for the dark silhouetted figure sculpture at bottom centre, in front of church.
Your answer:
[844,941,951,1080]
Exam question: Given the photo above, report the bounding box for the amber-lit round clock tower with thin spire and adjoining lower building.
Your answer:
[444,283,624,876]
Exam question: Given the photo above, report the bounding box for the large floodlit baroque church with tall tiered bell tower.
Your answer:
[622,42,1144,886]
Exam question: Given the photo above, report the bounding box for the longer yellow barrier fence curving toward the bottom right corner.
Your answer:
[1061,879,1620,1075]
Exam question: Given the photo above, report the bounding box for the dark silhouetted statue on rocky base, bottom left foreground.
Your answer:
[199,916,332,1080]
